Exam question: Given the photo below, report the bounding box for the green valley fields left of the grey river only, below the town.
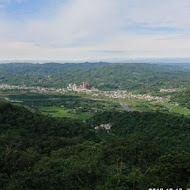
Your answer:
[4,93,122,119]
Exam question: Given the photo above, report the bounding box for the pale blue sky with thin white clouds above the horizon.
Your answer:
[0,0,190,61]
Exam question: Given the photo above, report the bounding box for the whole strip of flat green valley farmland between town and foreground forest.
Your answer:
[0,88,190,120]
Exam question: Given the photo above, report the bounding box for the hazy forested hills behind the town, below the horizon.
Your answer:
[0,63,190,92]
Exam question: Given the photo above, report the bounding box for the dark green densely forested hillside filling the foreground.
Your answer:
[0,104,190,190]
